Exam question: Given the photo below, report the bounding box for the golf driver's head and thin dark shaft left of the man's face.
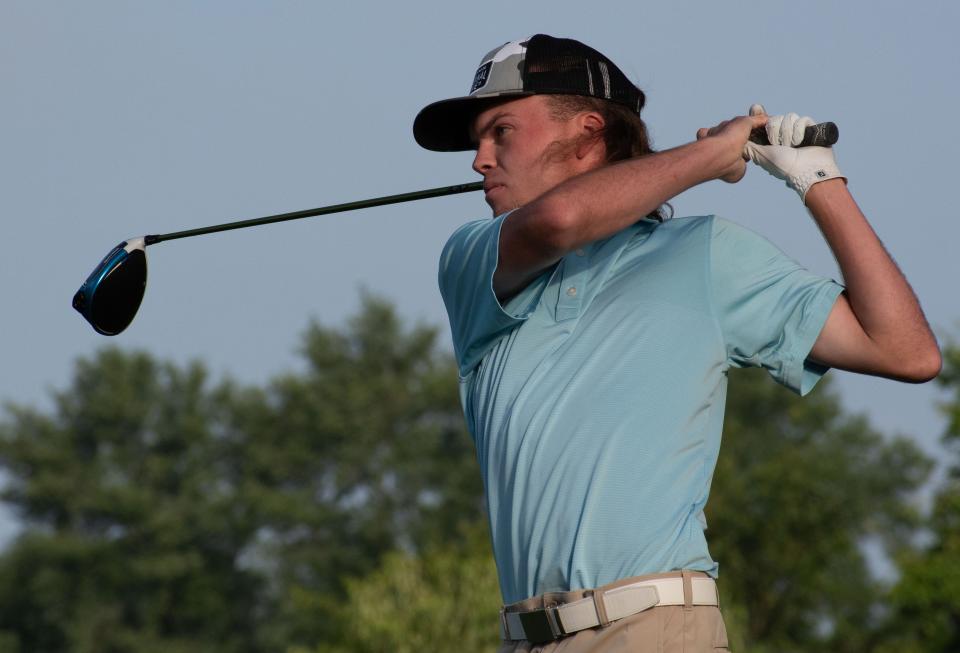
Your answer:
[73,181,483,336]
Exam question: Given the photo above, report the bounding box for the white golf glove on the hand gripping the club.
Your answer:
[743,104,846,201]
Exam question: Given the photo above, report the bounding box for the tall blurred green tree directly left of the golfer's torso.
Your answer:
[234,296,483,645]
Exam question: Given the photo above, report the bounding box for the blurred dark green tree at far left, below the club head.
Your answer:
[0,349,262,653]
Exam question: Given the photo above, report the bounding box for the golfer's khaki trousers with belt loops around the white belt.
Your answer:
[498,574,729,653]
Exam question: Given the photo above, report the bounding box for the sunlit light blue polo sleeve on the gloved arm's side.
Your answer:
[710,218,843,395]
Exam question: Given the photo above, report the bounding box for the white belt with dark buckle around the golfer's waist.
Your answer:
[500,576,720,644]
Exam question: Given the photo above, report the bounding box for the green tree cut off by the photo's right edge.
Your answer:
[885,345,960,653]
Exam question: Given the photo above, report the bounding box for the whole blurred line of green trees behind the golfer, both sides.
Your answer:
[0,296,960,653]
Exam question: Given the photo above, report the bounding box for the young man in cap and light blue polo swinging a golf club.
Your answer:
[414,35,940,652]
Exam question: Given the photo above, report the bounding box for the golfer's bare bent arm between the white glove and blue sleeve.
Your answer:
[805,179,940,381]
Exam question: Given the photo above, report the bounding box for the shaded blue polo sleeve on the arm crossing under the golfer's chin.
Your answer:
[438,213,549,377]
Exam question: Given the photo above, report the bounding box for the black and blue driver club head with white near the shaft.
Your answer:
[73,237,147,336]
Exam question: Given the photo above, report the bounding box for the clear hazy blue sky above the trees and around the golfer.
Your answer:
[0,0,960,536]
